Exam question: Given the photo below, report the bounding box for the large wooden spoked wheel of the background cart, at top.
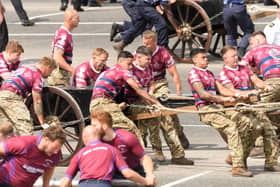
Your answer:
[165,0,212,63]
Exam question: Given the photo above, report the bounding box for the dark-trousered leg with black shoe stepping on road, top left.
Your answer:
[11,0,34,26]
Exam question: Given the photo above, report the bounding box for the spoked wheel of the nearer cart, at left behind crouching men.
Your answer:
[25,87,85,165]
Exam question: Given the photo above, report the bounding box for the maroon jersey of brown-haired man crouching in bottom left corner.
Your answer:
[0,136,61,187]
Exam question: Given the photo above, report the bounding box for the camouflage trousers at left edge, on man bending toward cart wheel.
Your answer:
[0,91,34,135]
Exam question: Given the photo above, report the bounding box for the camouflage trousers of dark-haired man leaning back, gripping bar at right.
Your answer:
[199,104,254,168]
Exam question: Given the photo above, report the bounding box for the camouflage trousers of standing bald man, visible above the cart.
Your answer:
[47,68,71,86]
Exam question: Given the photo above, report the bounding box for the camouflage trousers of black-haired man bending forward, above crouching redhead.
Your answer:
[89,97,144,145]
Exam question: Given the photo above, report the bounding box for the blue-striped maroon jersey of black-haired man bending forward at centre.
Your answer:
[92,64,133,100]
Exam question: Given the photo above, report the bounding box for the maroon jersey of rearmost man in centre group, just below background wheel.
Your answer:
[150,46,175,81]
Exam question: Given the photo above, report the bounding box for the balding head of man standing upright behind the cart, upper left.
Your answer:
[64,9,80,31]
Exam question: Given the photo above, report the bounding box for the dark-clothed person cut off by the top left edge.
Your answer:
[0,0,9,52]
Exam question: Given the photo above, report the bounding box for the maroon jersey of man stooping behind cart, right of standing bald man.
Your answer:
[73,61,109,88]
